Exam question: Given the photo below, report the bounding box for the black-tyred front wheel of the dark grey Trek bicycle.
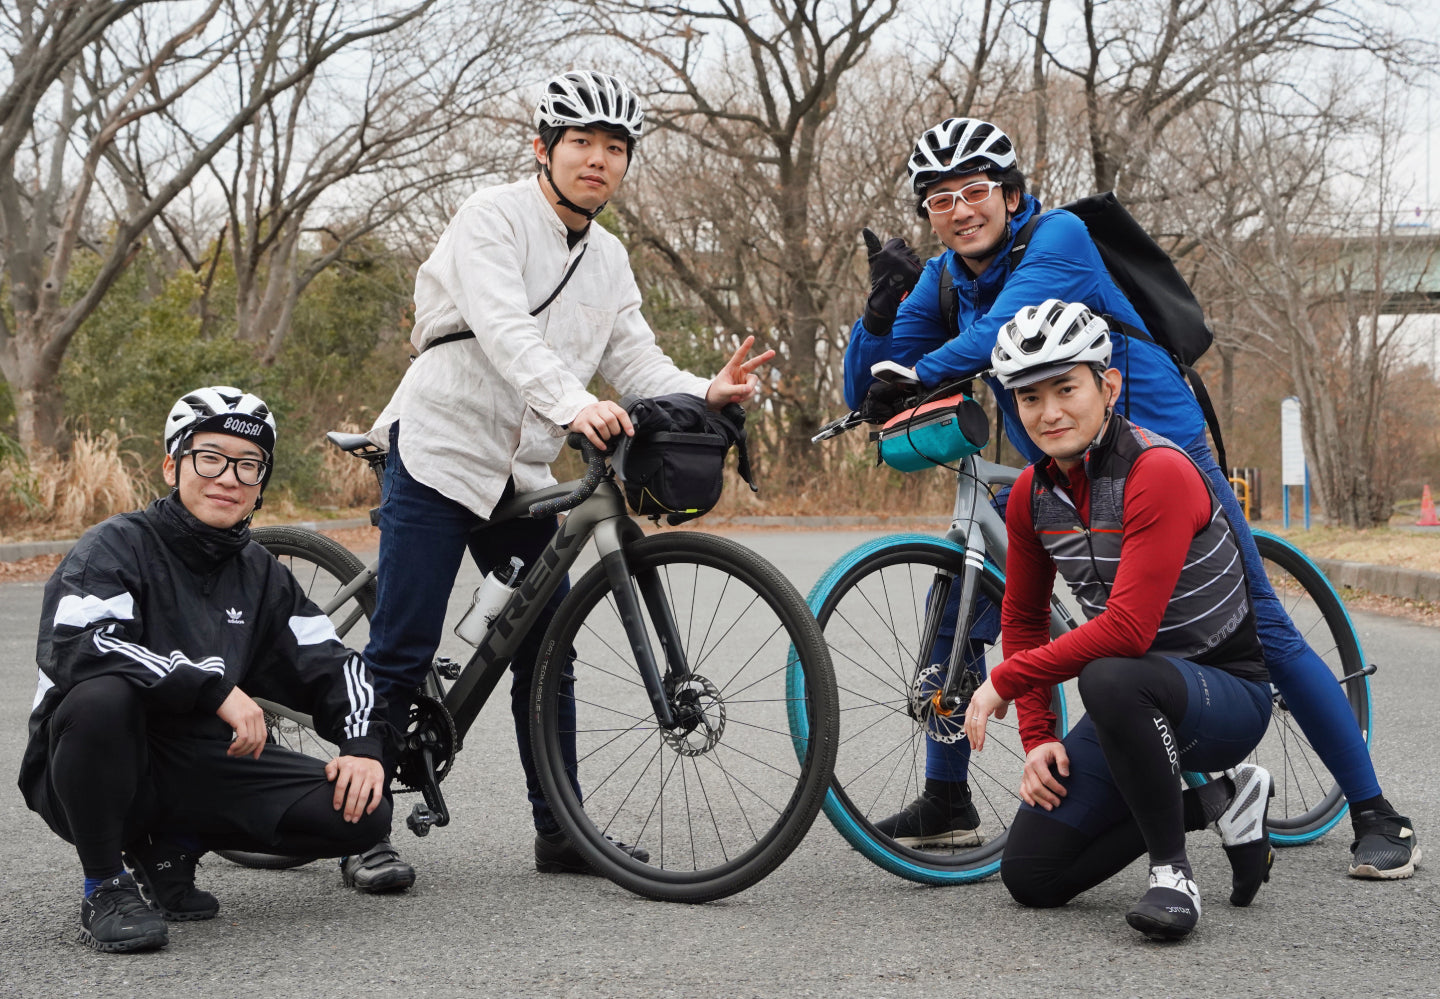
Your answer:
[531,533,838,903]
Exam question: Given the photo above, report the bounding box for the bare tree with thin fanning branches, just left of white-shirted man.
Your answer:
[165,0,549,363]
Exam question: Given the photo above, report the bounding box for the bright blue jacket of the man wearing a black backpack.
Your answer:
[845,194,1205,461]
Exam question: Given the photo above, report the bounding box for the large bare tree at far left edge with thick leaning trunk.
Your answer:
[0,0,433,452]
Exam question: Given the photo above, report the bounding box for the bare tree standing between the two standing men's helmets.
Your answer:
[567,0,899,469]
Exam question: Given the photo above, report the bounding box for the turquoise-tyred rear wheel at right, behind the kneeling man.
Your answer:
[1251,531,1372,846]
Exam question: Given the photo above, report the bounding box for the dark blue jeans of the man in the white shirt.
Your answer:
[364,423,579,833]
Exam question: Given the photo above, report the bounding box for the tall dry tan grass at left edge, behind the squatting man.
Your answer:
[0,430,150,540]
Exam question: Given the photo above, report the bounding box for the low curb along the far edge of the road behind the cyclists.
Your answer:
[11,517,1440,603]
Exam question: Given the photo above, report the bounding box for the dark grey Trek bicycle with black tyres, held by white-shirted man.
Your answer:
[218,433,840,903]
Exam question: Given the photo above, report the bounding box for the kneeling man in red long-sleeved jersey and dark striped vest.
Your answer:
[965,299,1273,940]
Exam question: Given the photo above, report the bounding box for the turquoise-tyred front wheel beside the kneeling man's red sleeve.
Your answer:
[811,534,1066,884]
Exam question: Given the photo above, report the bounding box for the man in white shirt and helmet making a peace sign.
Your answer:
[341,71,775,891]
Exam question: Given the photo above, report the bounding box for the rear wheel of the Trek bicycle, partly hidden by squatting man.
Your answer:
[215,527,376,871]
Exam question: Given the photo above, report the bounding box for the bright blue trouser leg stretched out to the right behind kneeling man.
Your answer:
[1185,438,1381,803]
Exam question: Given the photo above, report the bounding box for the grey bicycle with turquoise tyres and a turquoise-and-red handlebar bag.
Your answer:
[809,387,1375,884]
